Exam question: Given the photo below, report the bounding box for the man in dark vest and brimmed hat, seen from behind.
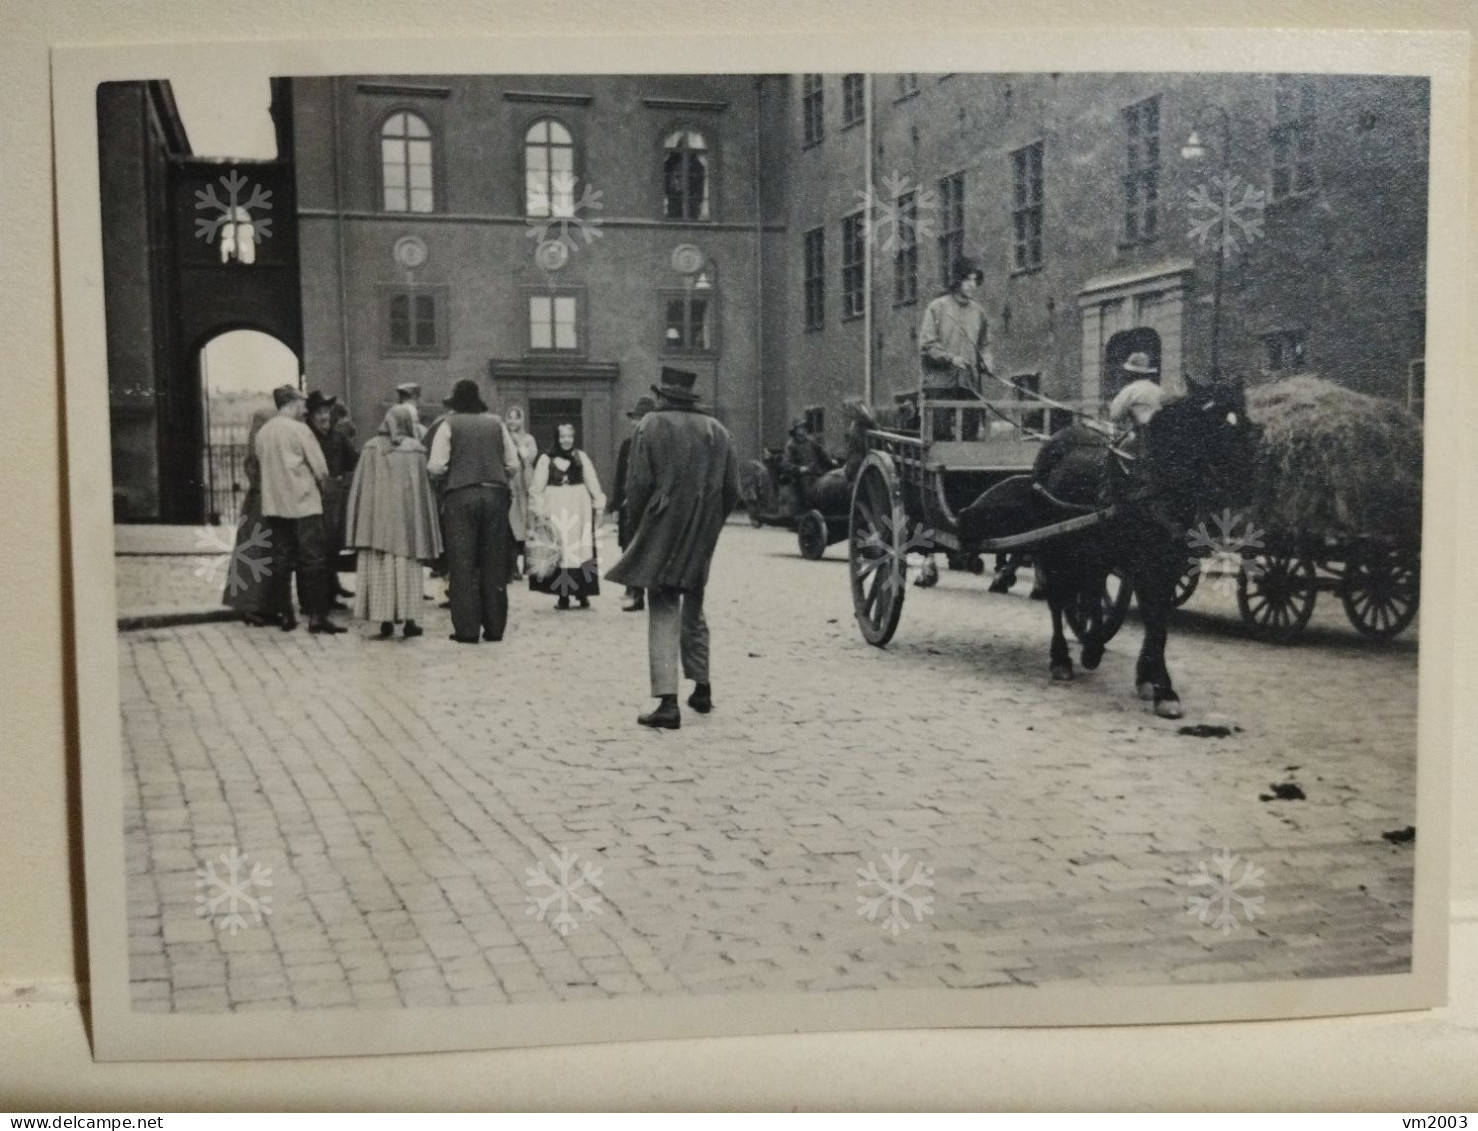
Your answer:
[426,380,519,645]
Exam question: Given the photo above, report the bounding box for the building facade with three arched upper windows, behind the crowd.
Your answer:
[293,75,788,482]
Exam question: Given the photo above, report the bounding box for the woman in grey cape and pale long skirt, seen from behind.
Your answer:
[344,404,442,639]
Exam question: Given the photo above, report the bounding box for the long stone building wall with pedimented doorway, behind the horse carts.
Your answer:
[786,74,1428,441]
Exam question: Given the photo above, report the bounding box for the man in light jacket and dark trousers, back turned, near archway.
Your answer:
[254,384,346,634]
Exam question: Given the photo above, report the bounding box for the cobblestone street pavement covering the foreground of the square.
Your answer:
[120,525,1417,1011]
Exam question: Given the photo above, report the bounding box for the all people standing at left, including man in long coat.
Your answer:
[225,368,739,729]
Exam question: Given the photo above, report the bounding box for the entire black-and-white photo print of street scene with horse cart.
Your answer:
[52,35,1456,1059]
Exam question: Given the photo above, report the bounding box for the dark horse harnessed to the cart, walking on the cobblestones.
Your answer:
[961,383,1256,719]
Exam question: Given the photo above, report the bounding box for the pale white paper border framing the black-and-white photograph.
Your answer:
[52,28,1472,1060]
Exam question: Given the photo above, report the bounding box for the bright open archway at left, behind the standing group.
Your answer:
[195,330,302,526]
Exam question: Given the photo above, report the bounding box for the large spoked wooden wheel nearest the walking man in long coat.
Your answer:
[847,452,913,648]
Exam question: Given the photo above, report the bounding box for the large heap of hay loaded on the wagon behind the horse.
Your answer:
[1247,376,1422,543]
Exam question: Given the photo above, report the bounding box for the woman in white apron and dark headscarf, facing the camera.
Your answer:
[529,423,606,609]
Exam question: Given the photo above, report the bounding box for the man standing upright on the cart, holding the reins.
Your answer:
[919,259,995,441]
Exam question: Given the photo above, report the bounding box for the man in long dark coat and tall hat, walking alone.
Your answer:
[606,367,739,730]
